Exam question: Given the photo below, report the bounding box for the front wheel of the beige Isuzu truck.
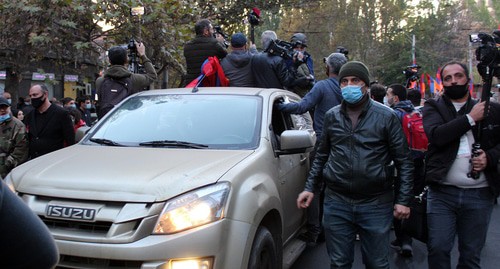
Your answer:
[248,226,279,269]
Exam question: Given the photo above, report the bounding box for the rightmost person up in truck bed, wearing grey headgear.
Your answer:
[287,33,315,97]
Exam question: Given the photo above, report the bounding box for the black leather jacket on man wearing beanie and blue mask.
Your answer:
[305,99,413,206]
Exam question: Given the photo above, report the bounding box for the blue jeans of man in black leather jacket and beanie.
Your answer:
[323,188,393,269]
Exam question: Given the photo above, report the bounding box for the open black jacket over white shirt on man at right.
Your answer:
[423,95,500,196]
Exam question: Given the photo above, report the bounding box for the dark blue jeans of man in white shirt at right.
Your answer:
[427,185,495,269]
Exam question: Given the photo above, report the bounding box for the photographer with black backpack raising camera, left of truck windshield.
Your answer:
[96,42,157,118]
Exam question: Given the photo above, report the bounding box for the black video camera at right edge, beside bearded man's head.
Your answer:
[469,30,500,78]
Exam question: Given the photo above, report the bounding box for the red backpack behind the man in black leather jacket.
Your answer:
[402,111,429,159]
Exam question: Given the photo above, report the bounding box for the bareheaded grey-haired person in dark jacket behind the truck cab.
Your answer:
[252,30,297,89]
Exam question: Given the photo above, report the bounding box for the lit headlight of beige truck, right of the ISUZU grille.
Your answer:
[153,182,230,234]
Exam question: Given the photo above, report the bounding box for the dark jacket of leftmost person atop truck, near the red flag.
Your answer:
[183,36,227,86]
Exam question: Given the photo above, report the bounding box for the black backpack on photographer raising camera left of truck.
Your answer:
[97,77,132,119]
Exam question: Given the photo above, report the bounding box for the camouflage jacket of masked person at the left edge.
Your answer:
[0,117,28,179]
